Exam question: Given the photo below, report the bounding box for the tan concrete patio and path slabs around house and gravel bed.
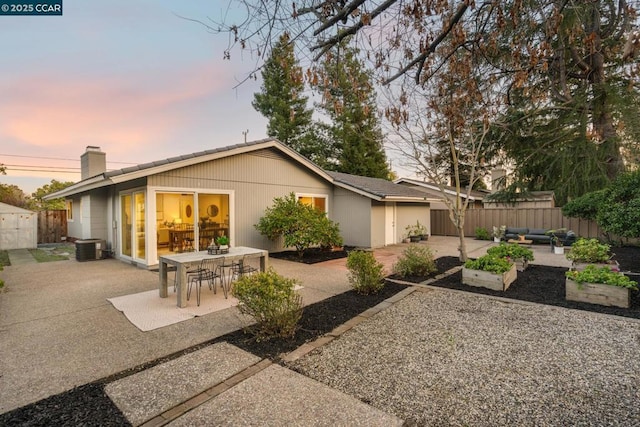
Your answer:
[0,237,568,425]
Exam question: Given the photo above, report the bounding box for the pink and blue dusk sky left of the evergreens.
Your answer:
[0,0,266,194]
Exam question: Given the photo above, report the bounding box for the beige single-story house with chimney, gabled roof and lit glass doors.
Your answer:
[47,139,430,266]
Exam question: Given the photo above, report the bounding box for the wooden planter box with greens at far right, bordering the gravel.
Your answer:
[565,265,638,308]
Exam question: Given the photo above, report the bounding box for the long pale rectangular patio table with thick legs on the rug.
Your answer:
[159,246,269,307]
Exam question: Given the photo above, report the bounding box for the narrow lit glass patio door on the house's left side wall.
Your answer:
[120,191,146,261]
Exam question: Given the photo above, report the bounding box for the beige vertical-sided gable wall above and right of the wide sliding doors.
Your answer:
[147,149,335,251]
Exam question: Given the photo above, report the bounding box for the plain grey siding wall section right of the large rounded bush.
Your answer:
[332,188,370,248]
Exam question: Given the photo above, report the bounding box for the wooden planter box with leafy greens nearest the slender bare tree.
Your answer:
[462,254,518,291]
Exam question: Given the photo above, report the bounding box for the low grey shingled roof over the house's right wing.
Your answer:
[327,171,429,202]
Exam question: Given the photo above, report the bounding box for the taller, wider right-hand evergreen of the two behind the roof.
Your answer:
[312,43,389,179]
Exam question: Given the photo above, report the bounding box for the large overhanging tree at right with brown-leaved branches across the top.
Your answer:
[220,0,640,198]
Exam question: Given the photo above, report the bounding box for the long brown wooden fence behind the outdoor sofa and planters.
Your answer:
[431,208,602,238]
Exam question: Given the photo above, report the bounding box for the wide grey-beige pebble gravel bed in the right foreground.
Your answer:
[289,290,640,426]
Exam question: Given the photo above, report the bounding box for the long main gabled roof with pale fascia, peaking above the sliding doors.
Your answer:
[45,138,331,200]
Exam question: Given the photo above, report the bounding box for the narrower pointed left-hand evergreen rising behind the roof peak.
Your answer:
[252,32,313,154]
